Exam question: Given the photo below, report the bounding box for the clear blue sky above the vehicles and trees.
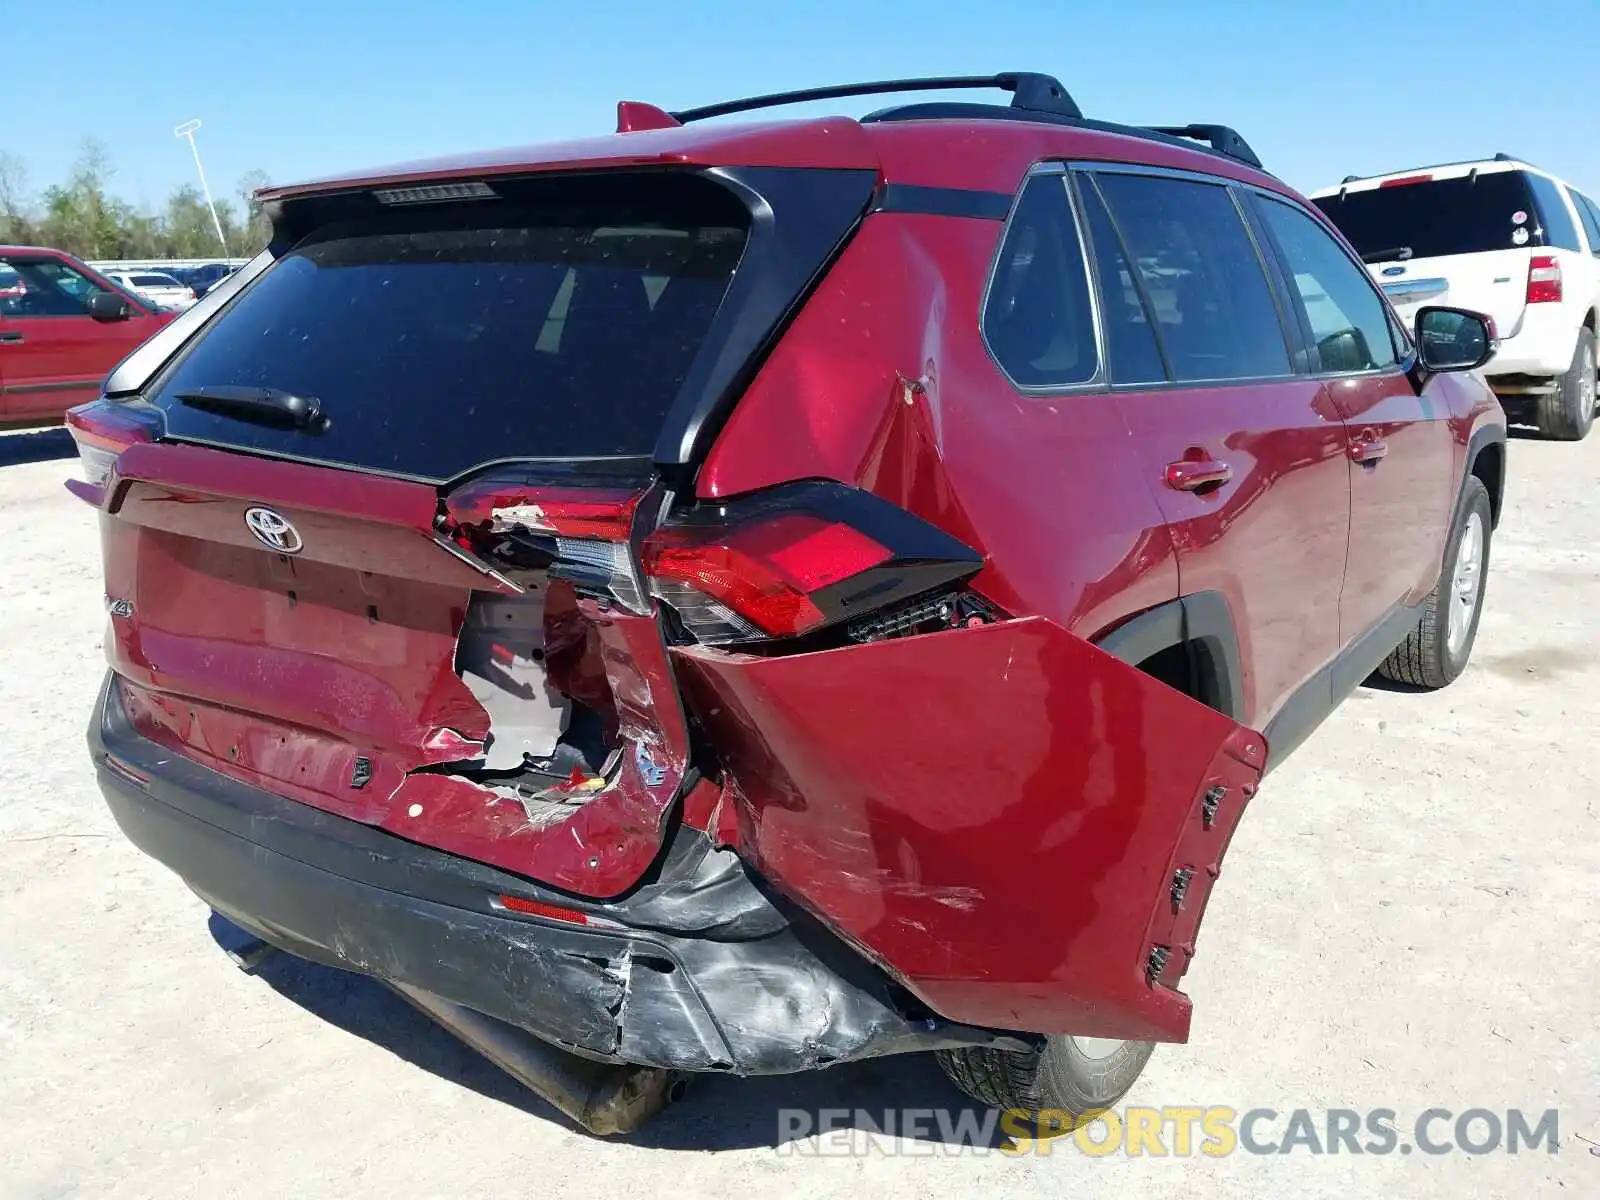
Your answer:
[0,0,1600,206]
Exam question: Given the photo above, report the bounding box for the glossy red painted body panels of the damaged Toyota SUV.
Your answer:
[90,104,1496,1040]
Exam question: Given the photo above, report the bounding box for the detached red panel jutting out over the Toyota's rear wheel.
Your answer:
[677,618,1264,1040]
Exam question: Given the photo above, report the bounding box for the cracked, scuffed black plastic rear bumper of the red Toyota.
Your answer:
[88,677,1032,1075]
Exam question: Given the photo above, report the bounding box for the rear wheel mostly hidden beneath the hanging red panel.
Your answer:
[934,1035,1155,1126]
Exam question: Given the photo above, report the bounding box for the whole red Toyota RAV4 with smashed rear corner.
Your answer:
[72,74,1504,1131]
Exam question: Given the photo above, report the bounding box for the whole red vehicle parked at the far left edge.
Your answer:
[0,246,173,429]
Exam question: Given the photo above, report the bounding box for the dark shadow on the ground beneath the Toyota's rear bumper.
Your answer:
[211,917,1005,1150]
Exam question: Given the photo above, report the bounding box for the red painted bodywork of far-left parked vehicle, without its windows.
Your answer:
[0,246,176,427]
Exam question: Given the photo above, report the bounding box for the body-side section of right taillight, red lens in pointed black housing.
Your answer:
[642,483,982,645]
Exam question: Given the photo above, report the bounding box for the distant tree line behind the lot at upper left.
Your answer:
[0,139,270,259]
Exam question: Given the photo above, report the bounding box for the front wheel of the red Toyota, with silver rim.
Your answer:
[1378,475,1491,688]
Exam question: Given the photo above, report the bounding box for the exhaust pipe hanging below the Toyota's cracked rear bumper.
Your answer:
[393,979,683,1138]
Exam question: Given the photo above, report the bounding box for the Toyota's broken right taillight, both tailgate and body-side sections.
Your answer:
[445,475,982,645]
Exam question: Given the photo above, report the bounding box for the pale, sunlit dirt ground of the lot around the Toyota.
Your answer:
[0,432,1600,1200]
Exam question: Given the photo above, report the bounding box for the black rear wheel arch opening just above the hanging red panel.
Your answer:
[1094,592,1245,722]
